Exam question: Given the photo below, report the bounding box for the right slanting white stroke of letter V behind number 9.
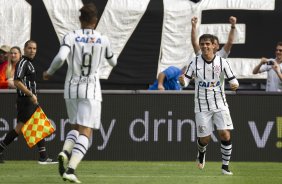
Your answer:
[97,0,150,79]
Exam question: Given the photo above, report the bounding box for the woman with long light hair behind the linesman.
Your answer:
[6,46,22,88]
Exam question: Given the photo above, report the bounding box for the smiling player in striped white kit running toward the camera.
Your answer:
[180,34,239,175]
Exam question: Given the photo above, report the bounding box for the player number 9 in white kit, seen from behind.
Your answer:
[43,3,117,183]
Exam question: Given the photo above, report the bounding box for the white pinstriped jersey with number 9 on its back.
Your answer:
[47,29,117,101]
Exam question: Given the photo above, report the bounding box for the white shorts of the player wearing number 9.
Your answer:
[65,99,101,129]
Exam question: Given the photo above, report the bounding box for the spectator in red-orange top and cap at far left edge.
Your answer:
[0,45,10,89]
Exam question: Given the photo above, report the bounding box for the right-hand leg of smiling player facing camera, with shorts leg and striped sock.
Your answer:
[215,110,233,175]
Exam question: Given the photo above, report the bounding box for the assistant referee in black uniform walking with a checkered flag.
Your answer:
[0,40,57,164]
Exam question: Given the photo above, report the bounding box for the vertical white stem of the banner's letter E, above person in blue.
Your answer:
[158,0,195,73]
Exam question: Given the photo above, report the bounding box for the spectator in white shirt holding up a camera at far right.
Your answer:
[253,42,282,92]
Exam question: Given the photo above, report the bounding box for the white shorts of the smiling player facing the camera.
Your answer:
[196,109,234,137]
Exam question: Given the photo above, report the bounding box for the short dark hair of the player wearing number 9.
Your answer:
[79,3,98,24]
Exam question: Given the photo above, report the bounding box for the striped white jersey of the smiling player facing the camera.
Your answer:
[185,55,238,112]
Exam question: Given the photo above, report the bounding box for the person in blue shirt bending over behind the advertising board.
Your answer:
[148,66,186,90]
